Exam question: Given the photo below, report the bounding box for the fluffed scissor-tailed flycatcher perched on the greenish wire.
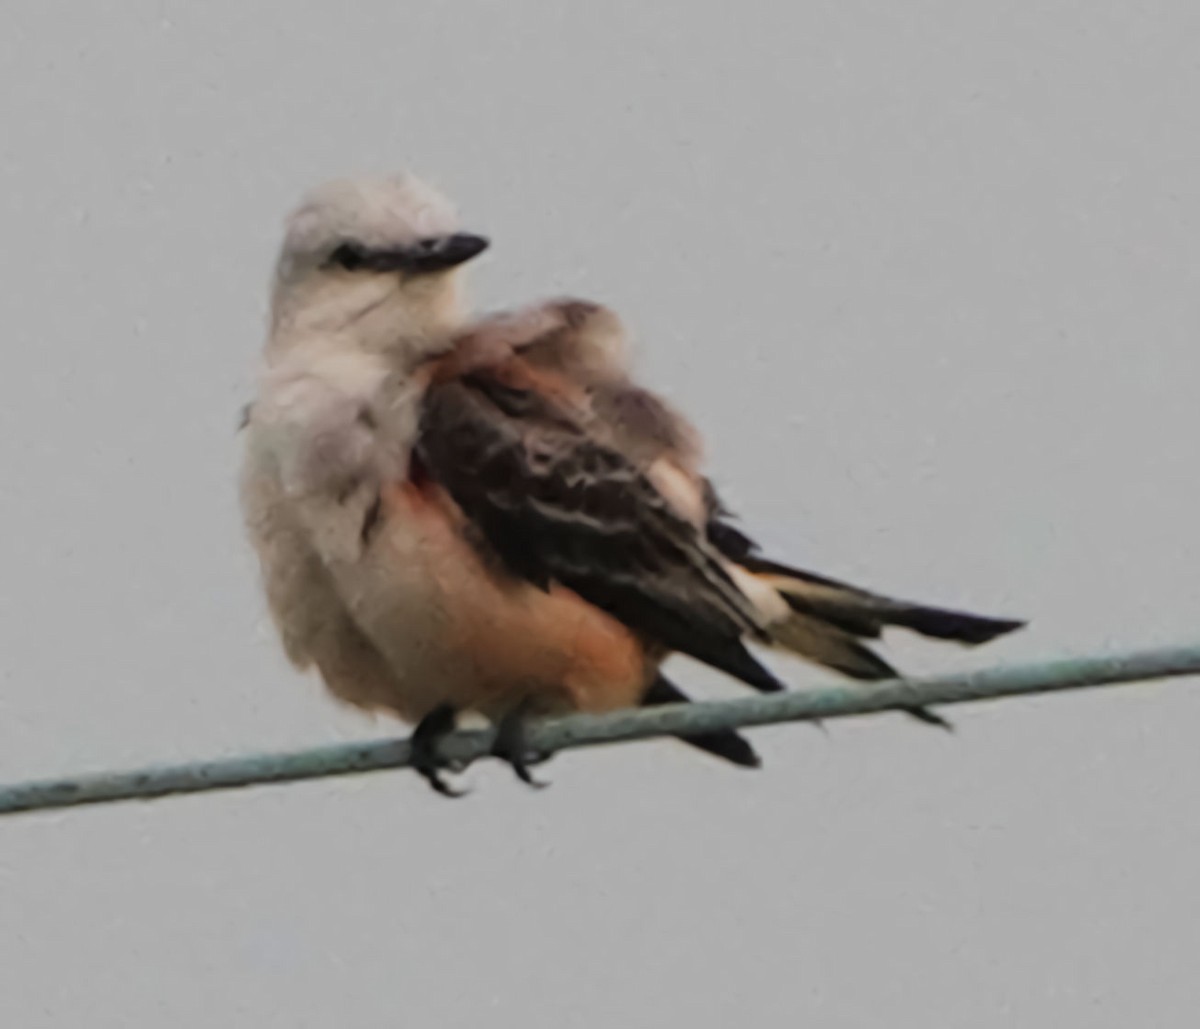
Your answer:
[242,176,1020,792]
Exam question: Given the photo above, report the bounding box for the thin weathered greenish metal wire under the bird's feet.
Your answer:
[0,644,1200,814]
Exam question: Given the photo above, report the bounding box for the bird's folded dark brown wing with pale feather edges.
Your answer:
[415,356,781,690]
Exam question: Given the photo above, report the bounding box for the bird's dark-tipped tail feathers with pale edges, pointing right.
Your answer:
[738,554,1025,728]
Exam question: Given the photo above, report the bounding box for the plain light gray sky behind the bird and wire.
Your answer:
[0,0,1200,1029]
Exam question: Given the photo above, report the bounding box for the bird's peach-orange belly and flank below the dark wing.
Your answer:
[343,483,650,717]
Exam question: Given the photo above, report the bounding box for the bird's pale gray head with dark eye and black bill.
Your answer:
[272,173,487,347]
